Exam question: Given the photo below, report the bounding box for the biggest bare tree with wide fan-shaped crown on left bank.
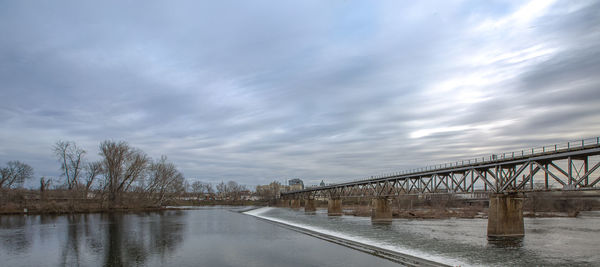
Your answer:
[100,140,149,205]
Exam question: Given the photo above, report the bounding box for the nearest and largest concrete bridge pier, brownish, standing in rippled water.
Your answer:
[488,193,525,240]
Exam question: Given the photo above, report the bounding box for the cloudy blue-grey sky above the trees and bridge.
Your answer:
[0,0,600,186]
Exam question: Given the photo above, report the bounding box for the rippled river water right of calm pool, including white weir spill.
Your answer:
[249,208,600,266]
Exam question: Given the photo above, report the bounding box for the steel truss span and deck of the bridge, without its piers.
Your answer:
[281,137,600,200]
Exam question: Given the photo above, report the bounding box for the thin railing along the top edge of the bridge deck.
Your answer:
[342,137,600,185]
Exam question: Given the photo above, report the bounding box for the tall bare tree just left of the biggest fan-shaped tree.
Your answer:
[54,140,86,190]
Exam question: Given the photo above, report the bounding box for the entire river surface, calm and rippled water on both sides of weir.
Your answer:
[0,207,600,266]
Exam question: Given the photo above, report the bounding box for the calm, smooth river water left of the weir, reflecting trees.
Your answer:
[0,207,397,267]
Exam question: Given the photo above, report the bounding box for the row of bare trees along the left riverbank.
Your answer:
[0,140,247,207]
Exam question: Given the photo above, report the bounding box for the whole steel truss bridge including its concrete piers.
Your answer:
[281,137,600,239]
